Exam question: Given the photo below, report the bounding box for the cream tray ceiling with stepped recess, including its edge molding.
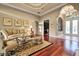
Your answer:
[2,3,65,16]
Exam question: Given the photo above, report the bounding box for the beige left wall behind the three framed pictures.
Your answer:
[0,5,39,33]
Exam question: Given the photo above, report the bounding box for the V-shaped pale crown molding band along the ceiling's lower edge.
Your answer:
[2,3,67,16]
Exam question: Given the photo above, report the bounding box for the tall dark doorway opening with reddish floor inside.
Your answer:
[44,20,49,41]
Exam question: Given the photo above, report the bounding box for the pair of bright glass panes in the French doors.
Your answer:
[65,19,78,35]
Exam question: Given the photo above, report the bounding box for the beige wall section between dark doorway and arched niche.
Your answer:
[41,9,60,36]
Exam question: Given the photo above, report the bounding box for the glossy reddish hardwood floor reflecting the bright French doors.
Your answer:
[33,36,79,56]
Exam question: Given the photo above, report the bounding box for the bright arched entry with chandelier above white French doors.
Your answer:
[58,5,79,36]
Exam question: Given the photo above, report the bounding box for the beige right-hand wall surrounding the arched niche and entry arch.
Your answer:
[41,3,79,37]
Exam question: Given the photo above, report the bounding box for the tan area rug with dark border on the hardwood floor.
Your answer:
[15,41,51,56]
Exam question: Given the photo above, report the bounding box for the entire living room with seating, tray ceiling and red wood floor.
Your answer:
[0,3,79,56]
